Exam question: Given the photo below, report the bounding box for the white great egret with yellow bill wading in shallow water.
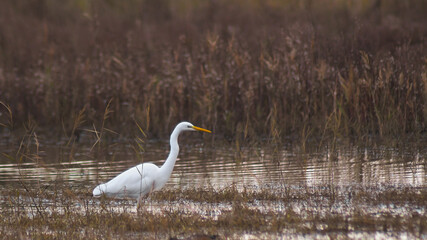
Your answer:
[93,122,211,200]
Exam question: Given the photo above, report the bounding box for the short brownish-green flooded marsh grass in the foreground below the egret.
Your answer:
[0,185,427,239]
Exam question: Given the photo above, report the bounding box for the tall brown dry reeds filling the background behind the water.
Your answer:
[0,0,427,141]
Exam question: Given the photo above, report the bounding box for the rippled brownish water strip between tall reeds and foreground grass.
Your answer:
[0,137,427,189]
